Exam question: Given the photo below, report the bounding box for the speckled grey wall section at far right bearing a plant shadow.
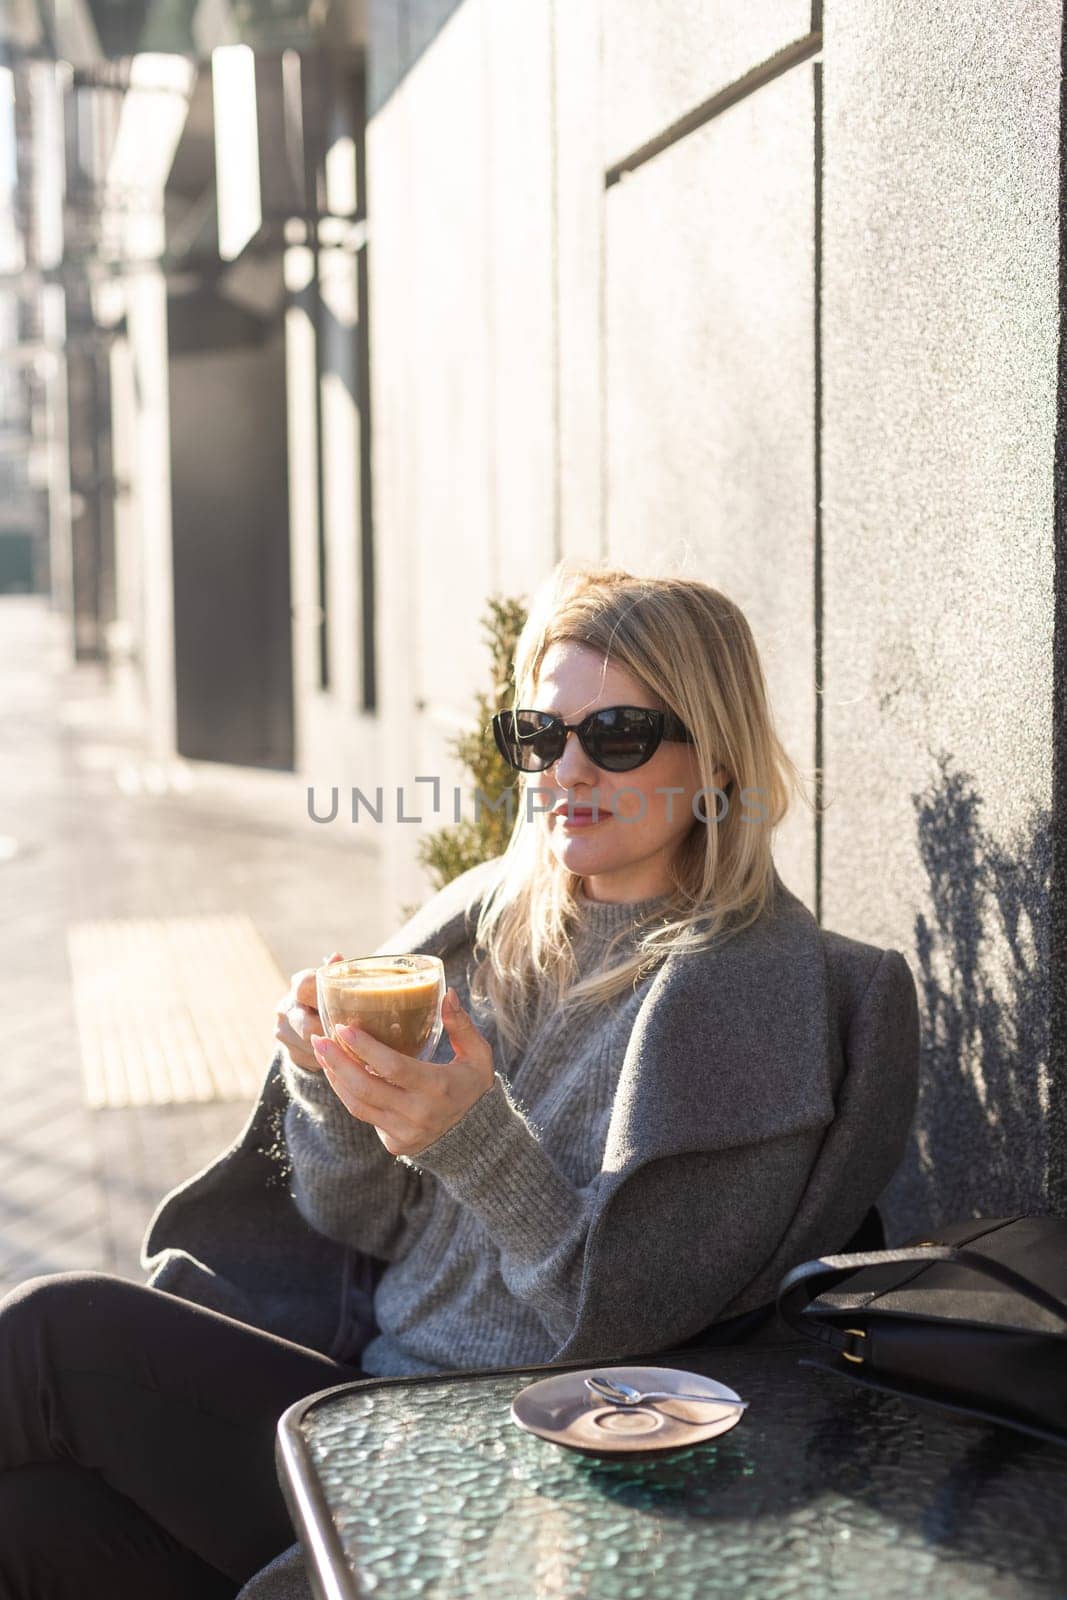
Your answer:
[822,0,1061,1232]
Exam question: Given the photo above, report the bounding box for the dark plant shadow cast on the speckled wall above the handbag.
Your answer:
[885,755,1053,1242]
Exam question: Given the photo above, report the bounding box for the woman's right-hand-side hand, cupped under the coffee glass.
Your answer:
[310,987,493,1155]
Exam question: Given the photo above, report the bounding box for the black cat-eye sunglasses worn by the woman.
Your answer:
[493,706,693,773]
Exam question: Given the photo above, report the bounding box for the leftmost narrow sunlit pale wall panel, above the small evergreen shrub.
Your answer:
[368,0,494,904]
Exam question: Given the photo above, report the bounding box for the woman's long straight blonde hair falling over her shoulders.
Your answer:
[470,562,811,1048]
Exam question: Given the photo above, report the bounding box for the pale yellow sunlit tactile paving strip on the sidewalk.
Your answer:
[67,914,286,1109]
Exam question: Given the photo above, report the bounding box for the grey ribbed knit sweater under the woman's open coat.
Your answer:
[283,896,665,1376]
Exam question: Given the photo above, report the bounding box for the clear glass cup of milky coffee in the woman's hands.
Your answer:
[315,955,446,1061]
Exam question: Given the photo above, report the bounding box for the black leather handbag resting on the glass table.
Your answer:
[777,1216,1067,1446]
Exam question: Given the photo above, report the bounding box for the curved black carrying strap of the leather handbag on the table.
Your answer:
[776,1245,1067,1362]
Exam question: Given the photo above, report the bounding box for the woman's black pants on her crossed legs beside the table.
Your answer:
[0,1272,365,1600]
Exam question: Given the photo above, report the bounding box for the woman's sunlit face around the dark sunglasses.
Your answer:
[526,643,726,904]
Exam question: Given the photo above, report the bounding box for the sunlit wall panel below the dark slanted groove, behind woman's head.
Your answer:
[605,66,814,906]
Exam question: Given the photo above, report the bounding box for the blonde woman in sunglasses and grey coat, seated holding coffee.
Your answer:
[0,566,918,1600]
